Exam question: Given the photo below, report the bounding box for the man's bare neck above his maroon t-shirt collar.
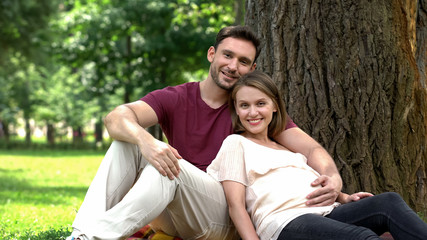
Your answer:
[200,77,229,109]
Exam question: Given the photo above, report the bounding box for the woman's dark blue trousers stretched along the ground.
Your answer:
[278,192,427,240]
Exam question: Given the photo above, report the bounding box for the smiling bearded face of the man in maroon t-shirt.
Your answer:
[208,37,256,90]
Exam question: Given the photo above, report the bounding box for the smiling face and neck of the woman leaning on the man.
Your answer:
[234,86,277,137]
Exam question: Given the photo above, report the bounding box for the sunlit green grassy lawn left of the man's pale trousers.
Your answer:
[0,150,105,240]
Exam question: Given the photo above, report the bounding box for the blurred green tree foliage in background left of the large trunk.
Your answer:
[0,0,235,146]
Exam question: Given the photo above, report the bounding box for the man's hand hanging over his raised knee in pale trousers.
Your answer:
[139,139,182,180]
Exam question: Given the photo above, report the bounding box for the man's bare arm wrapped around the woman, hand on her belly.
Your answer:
[276,127,342,206]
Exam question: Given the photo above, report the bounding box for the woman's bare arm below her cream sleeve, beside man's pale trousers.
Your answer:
[221,181,259,240]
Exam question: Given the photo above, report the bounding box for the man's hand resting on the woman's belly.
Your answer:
[306,175,341,207]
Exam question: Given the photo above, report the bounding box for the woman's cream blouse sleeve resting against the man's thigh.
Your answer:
[207,135,249,186]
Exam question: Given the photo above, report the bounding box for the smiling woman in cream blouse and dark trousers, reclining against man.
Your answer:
[207,71,427,240]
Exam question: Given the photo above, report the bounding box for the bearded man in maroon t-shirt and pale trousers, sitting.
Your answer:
[72,26,342,240]
